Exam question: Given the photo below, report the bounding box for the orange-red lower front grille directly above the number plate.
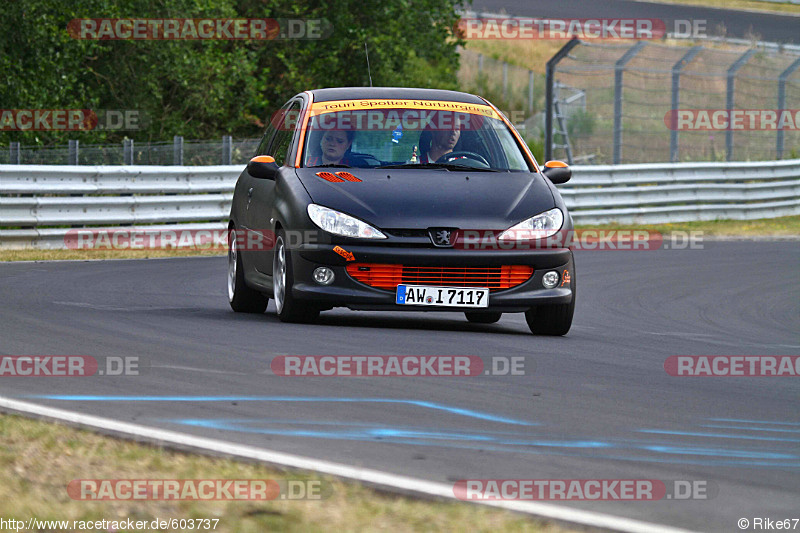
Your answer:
[347,263,533,291]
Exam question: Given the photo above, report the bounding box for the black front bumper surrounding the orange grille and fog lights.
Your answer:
[290,244,575,313]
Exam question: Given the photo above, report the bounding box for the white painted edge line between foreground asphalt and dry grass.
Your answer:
[0,396,691,533]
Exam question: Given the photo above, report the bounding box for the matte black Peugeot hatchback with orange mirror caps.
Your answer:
[228,87,576,335]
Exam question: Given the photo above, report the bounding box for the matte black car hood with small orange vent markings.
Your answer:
[297,168,555,230]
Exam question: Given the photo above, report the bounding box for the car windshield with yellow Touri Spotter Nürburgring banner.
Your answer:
[302,100,531,172]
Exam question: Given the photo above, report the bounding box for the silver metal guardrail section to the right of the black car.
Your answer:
[559,159,800,224]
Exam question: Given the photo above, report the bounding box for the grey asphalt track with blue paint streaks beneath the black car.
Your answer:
[0,242,800,531]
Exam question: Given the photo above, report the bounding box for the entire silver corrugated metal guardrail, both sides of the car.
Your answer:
[0,160,800,248]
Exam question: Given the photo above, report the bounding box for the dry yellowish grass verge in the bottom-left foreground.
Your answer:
[0,415,569,533]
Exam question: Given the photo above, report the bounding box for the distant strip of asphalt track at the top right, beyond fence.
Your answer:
[473,0,800,44]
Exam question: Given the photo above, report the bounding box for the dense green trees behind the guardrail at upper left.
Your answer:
[0,0,460,145]
